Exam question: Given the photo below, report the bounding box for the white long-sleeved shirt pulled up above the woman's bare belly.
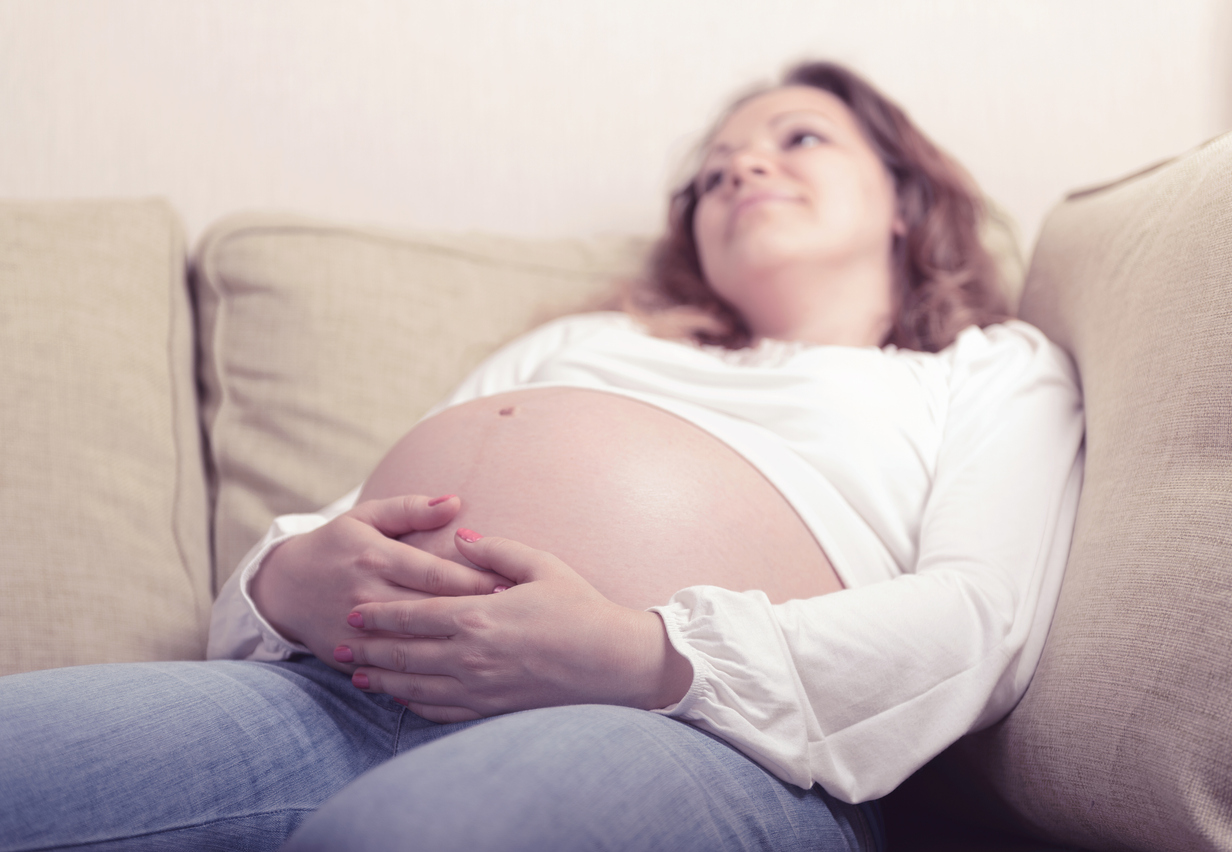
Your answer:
[208,313,1083,802]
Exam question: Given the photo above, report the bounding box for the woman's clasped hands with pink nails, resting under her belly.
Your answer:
[251,496,692,723]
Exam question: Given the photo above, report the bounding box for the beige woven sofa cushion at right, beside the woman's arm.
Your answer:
[958,134,1232,852]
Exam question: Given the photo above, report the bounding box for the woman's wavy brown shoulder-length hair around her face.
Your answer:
[626,62,1010,352]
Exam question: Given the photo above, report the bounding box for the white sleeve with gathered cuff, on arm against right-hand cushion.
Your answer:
[654,323,1083,803]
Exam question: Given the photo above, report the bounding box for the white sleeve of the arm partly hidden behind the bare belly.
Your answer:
[206,313,631,660]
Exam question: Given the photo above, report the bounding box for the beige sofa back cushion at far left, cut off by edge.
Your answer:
[0,201,211,673]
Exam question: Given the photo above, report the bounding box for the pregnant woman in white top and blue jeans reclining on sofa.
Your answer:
[0,63,1083,851]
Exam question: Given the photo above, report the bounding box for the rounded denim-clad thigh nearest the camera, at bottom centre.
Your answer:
[285,705,873,852]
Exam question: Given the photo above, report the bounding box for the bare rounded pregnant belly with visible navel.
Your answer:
[360,388,843,608]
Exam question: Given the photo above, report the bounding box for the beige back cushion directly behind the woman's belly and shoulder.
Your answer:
[195,214,644,593]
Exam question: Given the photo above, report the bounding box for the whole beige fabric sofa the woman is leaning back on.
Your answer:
[0,129,1232,852]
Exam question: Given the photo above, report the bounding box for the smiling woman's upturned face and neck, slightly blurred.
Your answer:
[694,86,903,344]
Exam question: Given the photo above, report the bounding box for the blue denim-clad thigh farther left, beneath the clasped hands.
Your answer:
[0,661,403,851]
